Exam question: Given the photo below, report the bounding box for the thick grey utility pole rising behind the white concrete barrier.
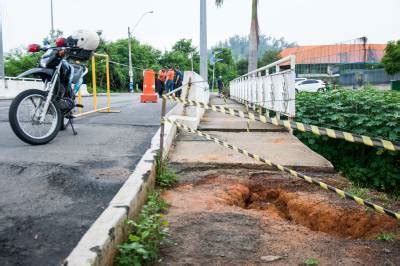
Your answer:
[200,0,208,81]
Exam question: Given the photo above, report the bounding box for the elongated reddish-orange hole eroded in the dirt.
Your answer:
[220,184,399,238]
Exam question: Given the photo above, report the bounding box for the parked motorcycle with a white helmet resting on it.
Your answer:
[9,31,99,145]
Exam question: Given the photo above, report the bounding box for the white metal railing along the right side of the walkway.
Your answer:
[229,55,296,117]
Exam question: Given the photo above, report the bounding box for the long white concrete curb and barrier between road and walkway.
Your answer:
[63,72,208,266]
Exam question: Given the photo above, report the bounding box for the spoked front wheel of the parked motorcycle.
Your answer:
[8,89,62,145]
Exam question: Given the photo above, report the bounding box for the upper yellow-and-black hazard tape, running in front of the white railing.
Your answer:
[163,95,400,151]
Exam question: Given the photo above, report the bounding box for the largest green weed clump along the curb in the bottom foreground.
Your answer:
[116,192,168,266]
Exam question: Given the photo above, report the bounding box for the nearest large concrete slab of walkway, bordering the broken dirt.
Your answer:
[170,131,334,172]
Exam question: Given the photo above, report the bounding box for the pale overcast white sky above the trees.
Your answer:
[0,0,400,51]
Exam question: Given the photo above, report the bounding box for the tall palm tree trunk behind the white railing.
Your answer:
[215,0,260,72]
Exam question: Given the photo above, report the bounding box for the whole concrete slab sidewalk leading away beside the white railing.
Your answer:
[170,95,334,172]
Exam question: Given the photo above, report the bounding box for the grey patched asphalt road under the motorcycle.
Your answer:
[0,94,171,266]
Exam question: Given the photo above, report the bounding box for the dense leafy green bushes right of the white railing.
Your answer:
[295,89,400,192]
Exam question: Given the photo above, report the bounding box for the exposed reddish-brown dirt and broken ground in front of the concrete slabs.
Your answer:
[160,169,400,265]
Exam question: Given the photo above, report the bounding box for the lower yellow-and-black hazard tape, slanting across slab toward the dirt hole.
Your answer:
[161,117,400,220]
